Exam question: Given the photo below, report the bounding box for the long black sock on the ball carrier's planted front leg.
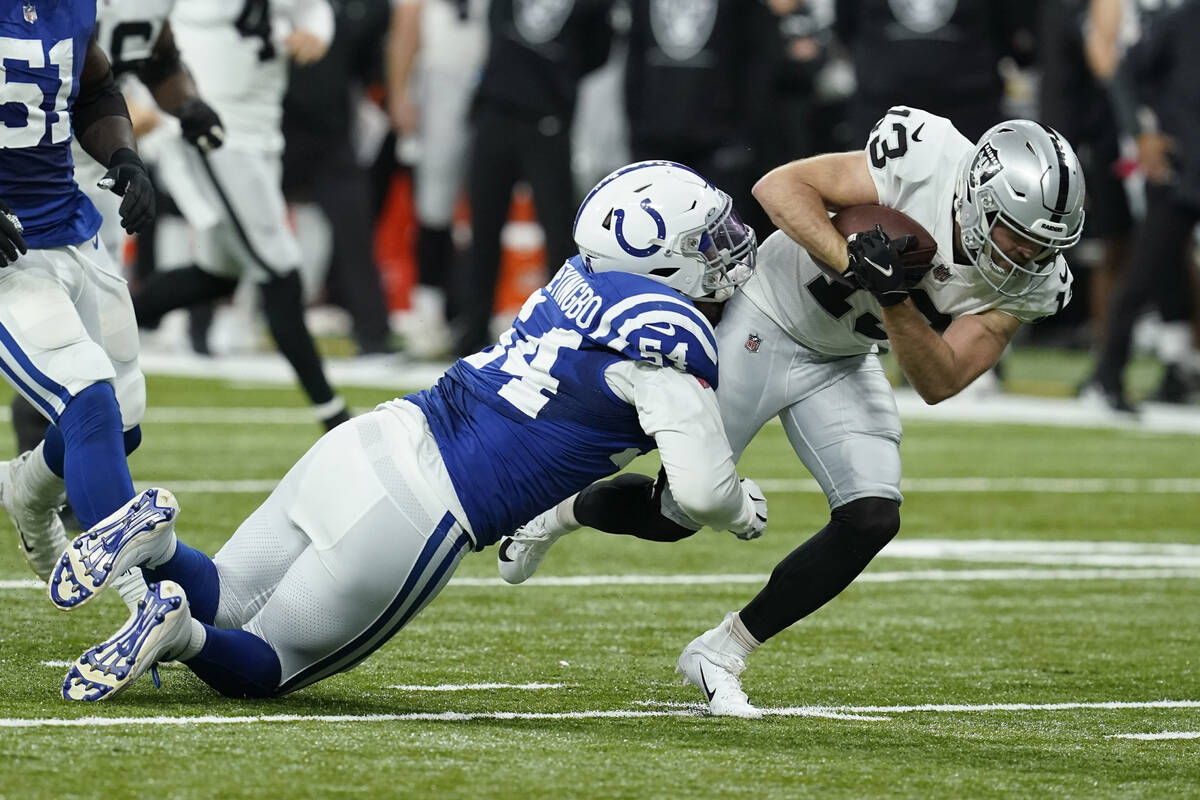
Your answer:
[739,498,900,642]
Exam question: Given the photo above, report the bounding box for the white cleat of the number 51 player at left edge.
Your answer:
[0,450,71,581]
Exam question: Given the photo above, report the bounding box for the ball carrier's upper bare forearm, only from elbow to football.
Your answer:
[752,161,850,272]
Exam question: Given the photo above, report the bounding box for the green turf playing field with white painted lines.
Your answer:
[0,365,1200,800]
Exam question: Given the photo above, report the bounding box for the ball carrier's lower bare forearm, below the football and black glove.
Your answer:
[883,300,974,405]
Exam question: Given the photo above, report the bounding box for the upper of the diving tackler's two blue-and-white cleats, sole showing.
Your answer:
[47,489,179,610]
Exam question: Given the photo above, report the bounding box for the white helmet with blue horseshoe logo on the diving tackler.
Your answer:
[574,161,758,302]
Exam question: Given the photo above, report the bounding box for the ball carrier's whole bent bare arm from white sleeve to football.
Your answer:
[752,150,880,272]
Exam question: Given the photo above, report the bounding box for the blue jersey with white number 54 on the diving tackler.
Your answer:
[406,257,716,548]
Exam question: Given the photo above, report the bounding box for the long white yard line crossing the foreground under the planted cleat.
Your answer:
[0,700,1200,738]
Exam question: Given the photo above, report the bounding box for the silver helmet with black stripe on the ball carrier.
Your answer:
[955,120,1084,297]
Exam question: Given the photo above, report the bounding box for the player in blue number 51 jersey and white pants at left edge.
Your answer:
[0,0,154,599]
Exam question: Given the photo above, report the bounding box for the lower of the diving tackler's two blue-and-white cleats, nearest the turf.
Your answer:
[62,581,192,702]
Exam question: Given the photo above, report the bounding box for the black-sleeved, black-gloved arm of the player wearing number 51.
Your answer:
[72,38,154,233]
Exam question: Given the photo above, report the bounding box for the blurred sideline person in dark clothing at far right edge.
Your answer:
[1084,0,1200,413]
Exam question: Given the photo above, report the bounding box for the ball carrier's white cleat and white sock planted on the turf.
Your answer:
[676,612,762,720]
